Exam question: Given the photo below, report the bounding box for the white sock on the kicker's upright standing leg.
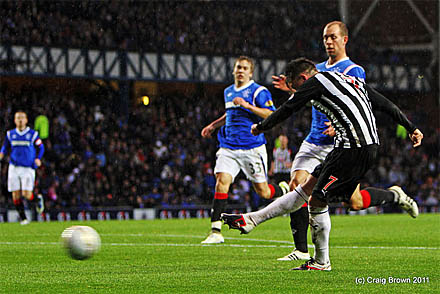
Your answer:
[309,206,332,264]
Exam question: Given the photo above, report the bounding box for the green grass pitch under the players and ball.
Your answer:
[0,214,440,294]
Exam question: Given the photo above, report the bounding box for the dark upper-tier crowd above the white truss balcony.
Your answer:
[0,0,404,63]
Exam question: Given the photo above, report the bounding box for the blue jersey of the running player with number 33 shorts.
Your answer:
[217,81,275,150]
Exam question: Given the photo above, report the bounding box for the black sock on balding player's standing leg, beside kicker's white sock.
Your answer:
[290,206,309,252]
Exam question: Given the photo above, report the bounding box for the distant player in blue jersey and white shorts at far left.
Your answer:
[0,110,44,225]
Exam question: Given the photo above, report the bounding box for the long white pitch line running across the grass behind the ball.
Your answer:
[0,242,440,250]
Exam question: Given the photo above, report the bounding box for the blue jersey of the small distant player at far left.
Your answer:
[0,127,44,169]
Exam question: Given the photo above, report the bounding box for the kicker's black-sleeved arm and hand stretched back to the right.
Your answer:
[366,85,423,147]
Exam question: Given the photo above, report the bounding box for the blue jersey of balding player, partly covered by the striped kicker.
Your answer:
[305,57,365,145]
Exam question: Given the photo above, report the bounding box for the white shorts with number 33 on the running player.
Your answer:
[214,145,267,183]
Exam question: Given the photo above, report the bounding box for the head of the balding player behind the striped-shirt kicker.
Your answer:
[322,21,348,61]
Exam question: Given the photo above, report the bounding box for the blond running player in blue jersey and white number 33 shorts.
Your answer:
[202,56,289,244]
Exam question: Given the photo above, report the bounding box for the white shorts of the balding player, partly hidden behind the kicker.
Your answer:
[290,141,333,176]
